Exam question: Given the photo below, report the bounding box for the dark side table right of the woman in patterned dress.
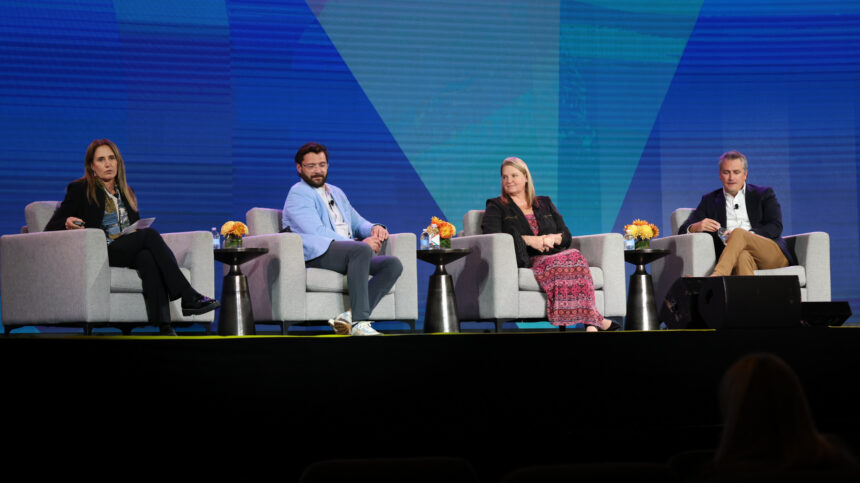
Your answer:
[624,249,671,330]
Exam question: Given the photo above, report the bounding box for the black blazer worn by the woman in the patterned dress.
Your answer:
[481,196,570,267]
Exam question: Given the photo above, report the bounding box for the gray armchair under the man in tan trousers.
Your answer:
[651,208,830,305]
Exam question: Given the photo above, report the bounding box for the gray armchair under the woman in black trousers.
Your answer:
[0,201,215,334]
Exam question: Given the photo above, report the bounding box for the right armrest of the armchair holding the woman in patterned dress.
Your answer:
[570,233,627,317]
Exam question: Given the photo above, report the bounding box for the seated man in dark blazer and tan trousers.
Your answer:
[678,151,797,276]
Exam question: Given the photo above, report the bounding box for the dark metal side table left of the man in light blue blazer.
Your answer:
[213,247,269,335]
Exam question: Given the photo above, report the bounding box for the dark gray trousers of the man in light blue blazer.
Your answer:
[305,241,403,322]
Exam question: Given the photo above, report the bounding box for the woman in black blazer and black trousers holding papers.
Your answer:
[45,139,221,335]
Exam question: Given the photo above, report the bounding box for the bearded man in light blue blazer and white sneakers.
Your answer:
[283,143,403,335]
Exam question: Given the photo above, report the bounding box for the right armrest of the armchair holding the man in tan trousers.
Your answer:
[784,231,831,302]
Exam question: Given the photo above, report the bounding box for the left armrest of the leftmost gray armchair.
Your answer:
[0,228,110,325]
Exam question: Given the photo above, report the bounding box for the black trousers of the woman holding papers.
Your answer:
[108,228,191,324]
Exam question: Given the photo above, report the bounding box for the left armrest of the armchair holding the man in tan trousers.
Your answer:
[651,233,717,306]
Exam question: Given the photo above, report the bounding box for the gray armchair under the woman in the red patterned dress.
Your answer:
[446,210,627,331]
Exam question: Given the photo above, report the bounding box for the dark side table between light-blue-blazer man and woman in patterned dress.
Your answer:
[416,248,472,333]
